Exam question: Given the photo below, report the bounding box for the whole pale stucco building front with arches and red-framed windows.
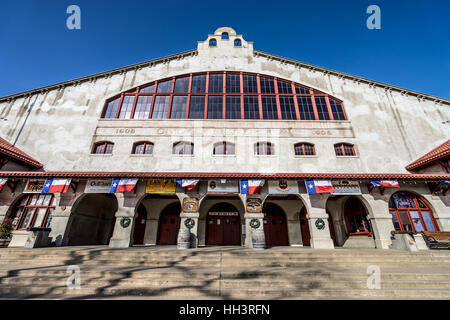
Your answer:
[0,28,450,249]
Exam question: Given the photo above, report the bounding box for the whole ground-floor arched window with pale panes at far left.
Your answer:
[11,194,55,230]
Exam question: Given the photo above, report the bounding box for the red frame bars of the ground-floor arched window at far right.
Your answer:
[389,191,440,233]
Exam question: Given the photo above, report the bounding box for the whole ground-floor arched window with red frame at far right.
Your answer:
[389,192,439,232]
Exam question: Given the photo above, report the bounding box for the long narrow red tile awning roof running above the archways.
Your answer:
[0,171,450,181]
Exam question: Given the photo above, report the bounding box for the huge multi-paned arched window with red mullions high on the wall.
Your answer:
[102,72,346,121]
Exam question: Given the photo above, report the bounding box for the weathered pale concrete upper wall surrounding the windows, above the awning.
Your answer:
[0,28,450,173]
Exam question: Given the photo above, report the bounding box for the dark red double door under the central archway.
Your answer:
[206,212,241,246]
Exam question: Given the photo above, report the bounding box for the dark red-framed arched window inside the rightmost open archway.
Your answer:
[344,198,372,235]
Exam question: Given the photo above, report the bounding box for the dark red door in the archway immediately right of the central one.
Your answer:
[263,203,289,247]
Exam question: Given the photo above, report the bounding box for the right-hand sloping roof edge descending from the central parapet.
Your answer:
[253,50,450,105]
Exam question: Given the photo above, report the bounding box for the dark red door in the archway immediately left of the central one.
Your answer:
[158,203,181,245]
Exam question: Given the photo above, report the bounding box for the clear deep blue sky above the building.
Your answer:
[0,0,450,99]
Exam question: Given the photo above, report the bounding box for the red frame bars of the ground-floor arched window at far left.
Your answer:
[11,193,56,230]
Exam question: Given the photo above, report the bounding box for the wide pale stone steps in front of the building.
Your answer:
[0,246,450,299]
